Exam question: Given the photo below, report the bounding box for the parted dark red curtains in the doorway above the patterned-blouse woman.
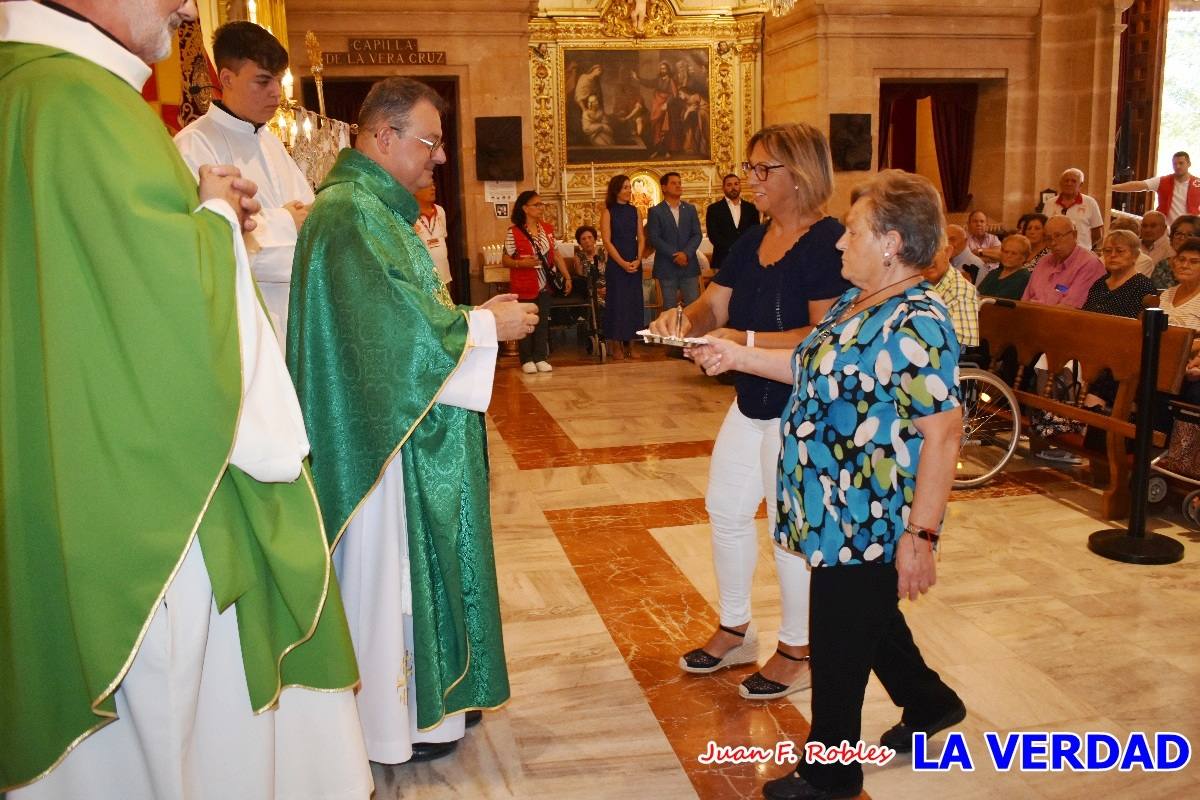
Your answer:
[878,83,979,211]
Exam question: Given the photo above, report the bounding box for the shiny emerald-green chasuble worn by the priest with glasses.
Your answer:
[288,149,509,729]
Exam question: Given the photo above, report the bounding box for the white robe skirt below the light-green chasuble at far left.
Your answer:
[8,540,373,800]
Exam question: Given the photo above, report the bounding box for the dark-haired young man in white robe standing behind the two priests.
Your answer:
[175,22,313,347]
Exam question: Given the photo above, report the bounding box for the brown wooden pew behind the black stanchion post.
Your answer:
[979,301,1193,519]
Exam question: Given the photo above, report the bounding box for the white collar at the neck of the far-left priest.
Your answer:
[0,0,151,92]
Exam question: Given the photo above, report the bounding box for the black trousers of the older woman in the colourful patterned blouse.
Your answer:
[798,564,959,790]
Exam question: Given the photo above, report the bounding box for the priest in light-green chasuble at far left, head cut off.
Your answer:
[0,0,372,800]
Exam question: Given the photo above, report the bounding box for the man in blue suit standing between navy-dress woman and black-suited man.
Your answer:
[646,173,701,307]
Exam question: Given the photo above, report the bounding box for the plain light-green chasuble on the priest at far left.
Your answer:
[0,43,358,792]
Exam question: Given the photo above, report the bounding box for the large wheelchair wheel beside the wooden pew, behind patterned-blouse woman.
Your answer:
[954,369,1021,489]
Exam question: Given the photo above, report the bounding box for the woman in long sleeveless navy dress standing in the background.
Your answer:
[600,175,646,359]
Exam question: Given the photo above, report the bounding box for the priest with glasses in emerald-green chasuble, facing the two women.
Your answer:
[287,78,536,764]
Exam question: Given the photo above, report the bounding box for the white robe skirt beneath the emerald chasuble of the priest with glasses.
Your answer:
[334,455,466,764]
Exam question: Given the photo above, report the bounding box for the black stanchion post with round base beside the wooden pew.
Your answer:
[1087,308,1183,564]
